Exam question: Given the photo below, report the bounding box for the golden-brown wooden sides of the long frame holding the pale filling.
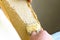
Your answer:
[0,0,39,40]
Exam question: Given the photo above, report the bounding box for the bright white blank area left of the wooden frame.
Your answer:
[0,9,21,40]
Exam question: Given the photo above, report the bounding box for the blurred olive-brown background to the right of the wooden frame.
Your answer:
[31,0,60,34]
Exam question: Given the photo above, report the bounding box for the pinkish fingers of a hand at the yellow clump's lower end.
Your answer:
[30,30,53,40]
